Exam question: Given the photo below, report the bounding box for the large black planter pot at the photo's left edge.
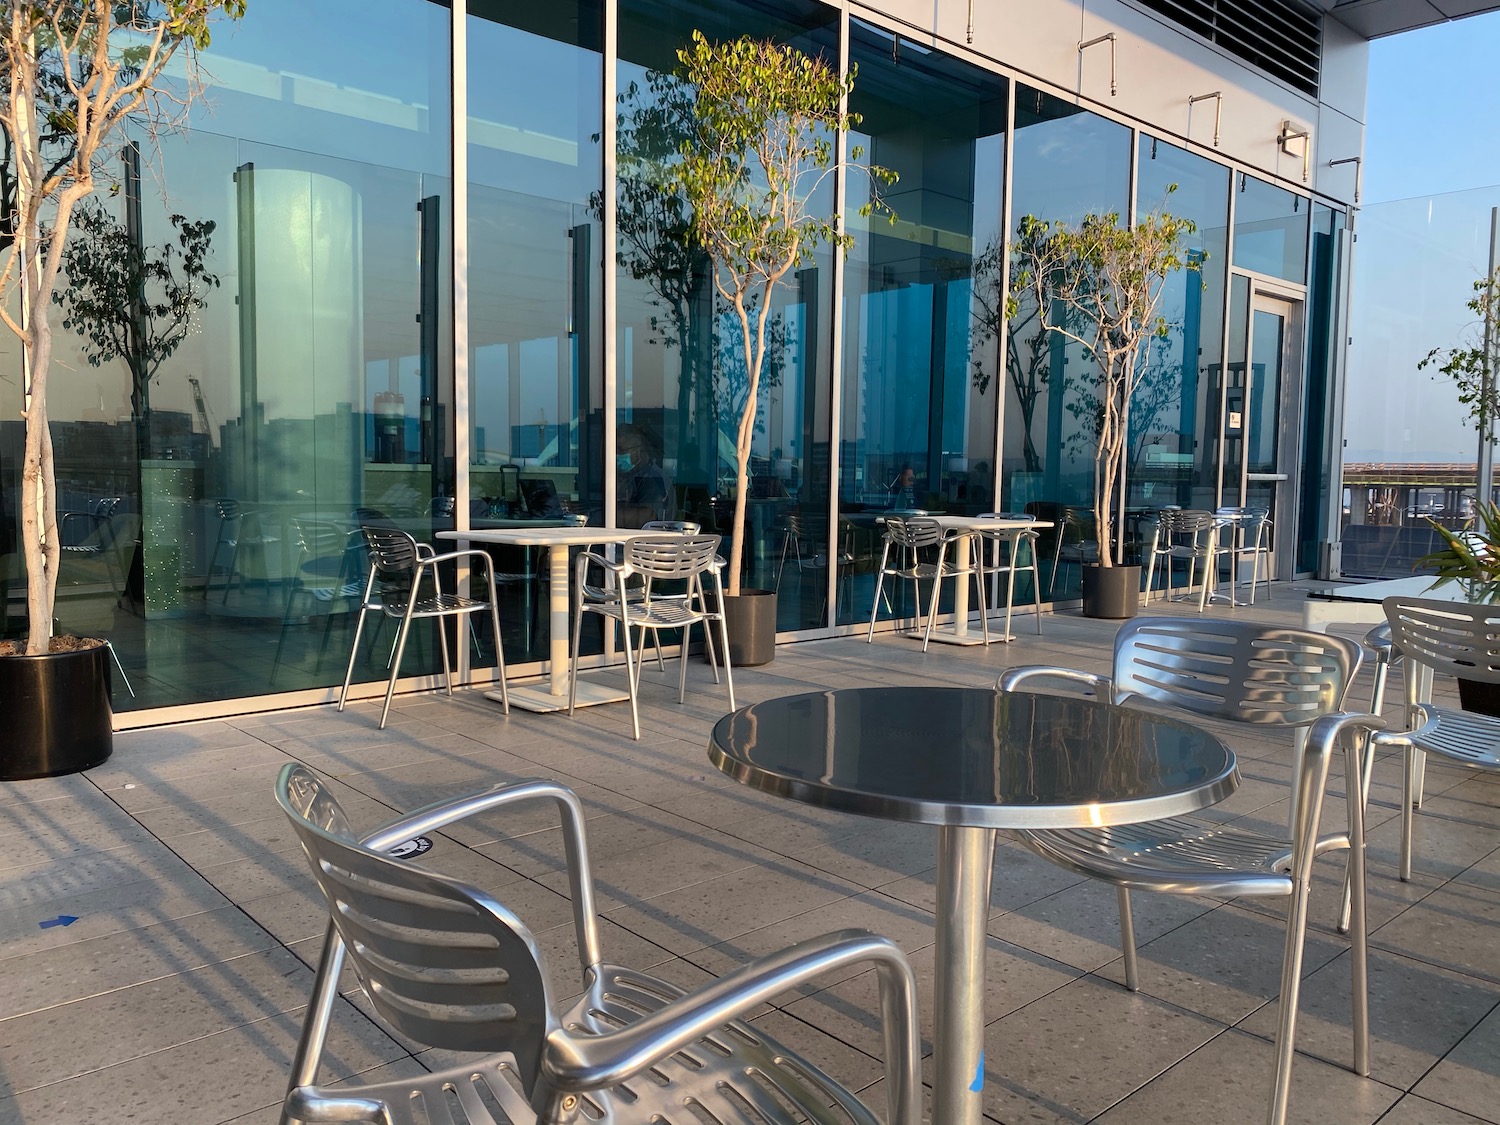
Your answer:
[0,644,114,782]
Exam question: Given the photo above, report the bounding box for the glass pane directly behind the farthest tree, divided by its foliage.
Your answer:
[1001,86,1131,597]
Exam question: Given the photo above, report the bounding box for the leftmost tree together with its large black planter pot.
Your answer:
[0,0,245,780]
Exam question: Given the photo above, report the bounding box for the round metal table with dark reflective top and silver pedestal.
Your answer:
[708,687,1239,1125]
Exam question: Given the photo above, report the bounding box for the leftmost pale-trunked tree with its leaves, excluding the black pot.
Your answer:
[0,0,245,654]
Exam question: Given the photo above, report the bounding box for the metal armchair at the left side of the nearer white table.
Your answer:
[339,525,510,731]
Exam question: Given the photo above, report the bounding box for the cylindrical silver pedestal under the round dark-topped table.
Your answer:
[933,827,995,1125]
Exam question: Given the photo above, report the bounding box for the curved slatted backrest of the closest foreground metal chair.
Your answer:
[276,765,552,1092]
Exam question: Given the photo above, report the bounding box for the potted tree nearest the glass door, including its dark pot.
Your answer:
[1007,210,1197,618]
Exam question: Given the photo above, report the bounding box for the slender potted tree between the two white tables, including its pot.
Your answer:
[674,32,896,665]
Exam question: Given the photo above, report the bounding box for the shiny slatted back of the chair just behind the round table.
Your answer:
[1113,617,1364,726]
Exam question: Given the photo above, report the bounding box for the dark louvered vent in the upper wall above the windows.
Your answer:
[1136,0,1323,98]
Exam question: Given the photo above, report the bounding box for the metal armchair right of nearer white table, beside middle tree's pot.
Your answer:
[567,536,735,741]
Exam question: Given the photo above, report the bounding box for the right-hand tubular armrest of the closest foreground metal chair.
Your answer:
[539,930,921,1125]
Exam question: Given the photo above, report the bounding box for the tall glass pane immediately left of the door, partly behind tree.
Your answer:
[1127,137,1230,537]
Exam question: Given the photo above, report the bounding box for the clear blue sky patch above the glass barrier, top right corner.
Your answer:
[1364,14,1500,206]
